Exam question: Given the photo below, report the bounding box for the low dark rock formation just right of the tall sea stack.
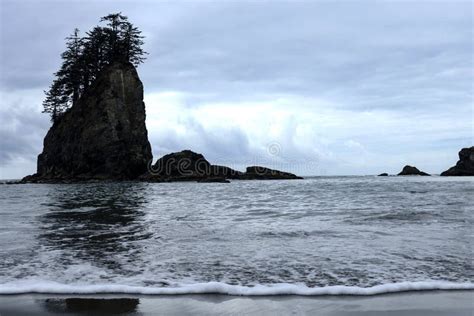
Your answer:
[140,150,302,182]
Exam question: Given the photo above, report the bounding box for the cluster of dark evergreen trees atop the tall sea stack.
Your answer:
[43,13,147,122]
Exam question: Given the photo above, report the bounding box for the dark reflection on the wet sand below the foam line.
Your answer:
[38,298,140,315]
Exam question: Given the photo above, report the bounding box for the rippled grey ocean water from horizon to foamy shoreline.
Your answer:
[0,176,474,295]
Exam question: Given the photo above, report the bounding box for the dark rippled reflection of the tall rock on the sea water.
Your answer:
[38,183,152,269]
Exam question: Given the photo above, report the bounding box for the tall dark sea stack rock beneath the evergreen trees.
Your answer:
[24,62,152,181]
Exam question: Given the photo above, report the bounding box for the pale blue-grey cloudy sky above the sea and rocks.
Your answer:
[0,0,474,178]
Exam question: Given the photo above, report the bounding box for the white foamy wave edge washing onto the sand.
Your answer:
[0,281,474,296]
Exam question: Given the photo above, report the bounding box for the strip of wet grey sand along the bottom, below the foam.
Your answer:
[0,291,474,316]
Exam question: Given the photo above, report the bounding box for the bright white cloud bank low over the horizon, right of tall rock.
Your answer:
[145,91,471,174]
